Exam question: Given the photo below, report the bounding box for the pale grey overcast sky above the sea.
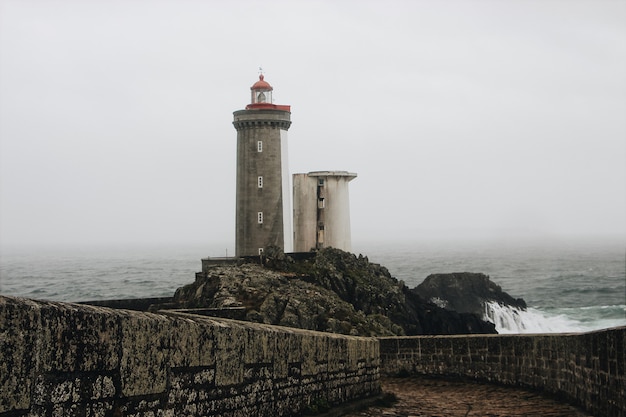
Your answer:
[0,0,626,253]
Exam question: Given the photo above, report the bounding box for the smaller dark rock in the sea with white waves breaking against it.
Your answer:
[413,272,526,317]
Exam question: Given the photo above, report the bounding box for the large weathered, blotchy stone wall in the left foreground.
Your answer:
[0,297,380,417]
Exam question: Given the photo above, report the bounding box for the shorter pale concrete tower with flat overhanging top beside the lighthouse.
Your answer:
[293,171,357,252]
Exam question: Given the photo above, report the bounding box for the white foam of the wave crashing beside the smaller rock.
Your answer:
[484,302,589,334]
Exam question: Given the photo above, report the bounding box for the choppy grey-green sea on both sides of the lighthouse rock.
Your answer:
[0,240,626,333]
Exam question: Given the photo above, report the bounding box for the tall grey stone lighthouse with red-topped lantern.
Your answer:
[233,74,293,256]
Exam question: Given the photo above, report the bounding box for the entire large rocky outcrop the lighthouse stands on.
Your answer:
[169,248,496,336]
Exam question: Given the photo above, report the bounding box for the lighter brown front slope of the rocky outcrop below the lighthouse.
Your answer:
[174,264,398,336]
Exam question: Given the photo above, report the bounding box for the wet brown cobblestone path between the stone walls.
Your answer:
[347,377,591,417]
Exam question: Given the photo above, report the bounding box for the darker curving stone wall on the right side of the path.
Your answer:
[379,327,626,417]
